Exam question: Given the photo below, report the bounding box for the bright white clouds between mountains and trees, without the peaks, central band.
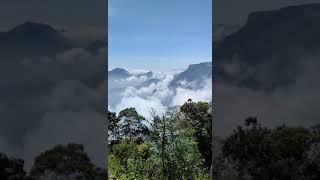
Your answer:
[108,67,212,118]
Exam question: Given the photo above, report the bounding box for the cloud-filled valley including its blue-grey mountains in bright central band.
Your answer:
[108,63,212,118]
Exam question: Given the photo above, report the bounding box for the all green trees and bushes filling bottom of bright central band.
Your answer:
[108,100,212,179]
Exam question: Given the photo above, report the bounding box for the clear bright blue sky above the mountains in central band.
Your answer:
[108,0,212,71]
